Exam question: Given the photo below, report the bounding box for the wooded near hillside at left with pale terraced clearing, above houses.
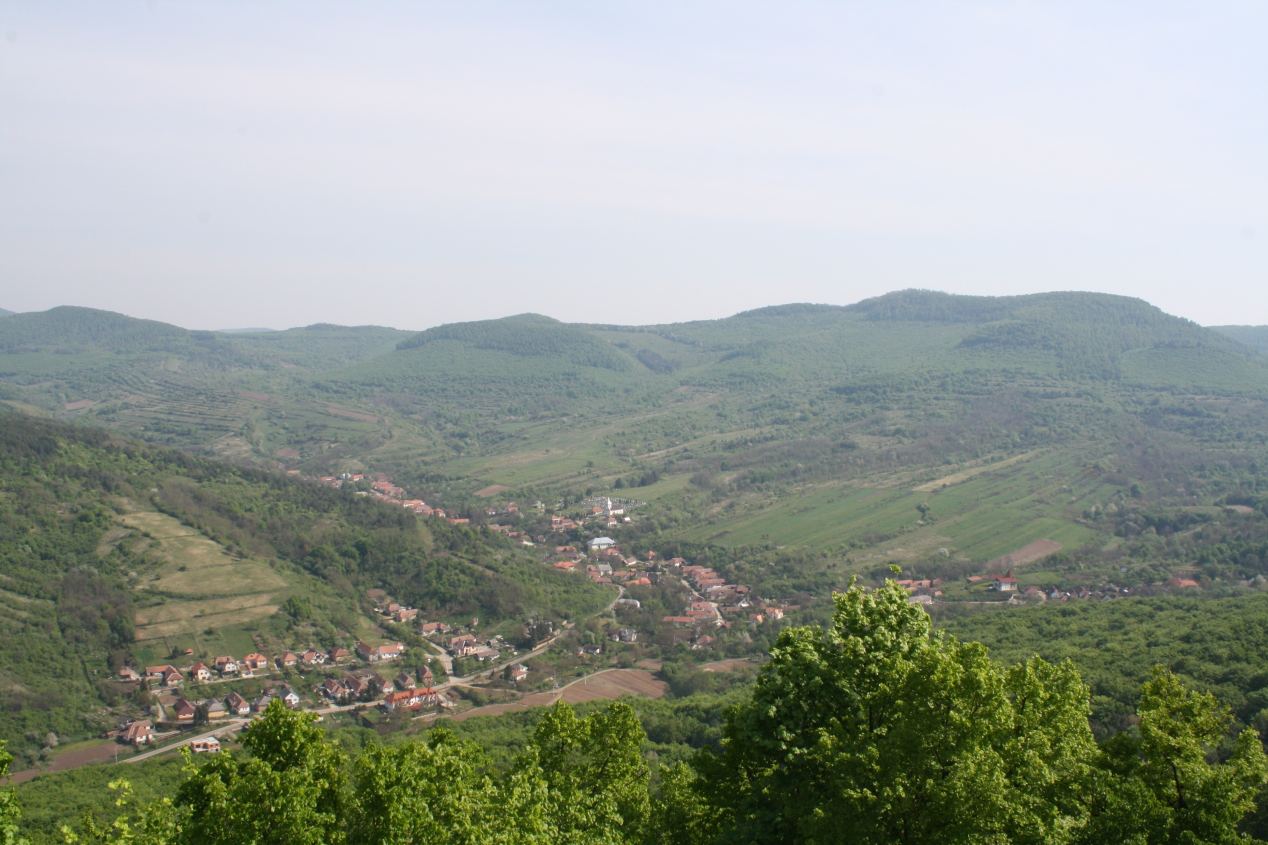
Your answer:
[0,412,610,755]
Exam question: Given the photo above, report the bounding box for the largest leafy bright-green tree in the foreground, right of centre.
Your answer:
[700,581,1096,845]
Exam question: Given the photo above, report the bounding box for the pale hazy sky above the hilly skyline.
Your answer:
[0,0,1268,329]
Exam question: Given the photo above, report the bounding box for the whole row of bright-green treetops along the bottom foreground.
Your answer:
[0,573,1268,845]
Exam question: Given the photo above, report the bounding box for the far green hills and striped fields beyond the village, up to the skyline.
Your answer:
[0,284,1268,586]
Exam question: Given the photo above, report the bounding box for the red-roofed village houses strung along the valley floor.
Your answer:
[96,469,1200,759]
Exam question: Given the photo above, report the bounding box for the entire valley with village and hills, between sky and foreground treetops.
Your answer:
[0,292,1268,842]
